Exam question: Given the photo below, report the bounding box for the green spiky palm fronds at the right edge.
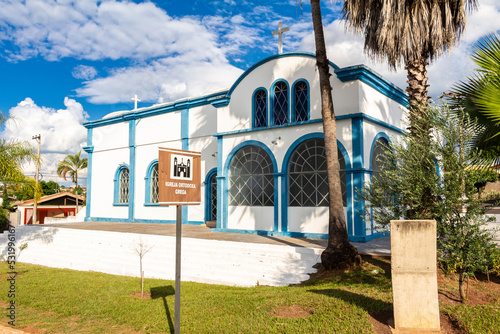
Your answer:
[447,33,500,163]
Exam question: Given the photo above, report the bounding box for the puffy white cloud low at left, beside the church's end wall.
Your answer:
[0,97,88,181]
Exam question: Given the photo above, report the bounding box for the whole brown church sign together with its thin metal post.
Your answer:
[158,147,201,334]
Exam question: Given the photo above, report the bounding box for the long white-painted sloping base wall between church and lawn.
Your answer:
[0,223,322,286]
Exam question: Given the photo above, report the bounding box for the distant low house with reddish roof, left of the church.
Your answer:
[11,192,85,225]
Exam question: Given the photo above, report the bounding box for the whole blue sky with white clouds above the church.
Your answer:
[0,0,500,184]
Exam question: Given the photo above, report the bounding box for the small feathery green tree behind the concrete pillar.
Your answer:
[360,107,500,301]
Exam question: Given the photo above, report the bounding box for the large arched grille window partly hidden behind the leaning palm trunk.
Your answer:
[288,138,347,206]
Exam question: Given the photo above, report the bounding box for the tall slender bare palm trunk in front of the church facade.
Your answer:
[311,0,361,269]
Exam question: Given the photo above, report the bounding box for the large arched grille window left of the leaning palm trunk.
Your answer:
[229,145,274,206]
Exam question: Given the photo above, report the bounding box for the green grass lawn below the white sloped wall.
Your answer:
[0,258,500,333]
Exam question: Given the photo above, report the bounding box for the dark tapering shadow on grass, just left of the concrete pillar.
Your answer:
[309,289,393,324]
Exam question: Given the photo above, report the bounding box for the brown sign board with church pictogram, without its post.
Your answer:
[158,147,201,205]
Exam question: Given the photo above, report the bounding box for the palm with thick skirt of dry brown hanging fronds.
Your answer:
[342,0,477,133]
